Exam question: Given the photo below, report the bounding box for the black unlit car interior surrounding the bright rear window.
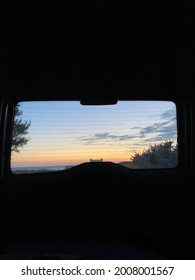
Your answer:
[0,1,195,260]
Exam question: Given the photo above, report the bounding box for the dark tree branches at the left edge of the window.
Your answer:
[11,104,31,153]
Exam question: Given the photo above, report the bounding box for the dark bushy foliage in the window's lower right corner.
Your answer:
[131,140,178,169]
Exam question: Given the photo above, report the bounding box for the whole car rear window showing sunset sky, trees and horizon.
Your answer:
[10,100,178,174]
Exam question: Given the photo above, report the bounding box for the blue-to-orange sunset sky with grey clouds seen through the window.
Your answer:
[11,101,177,167]
